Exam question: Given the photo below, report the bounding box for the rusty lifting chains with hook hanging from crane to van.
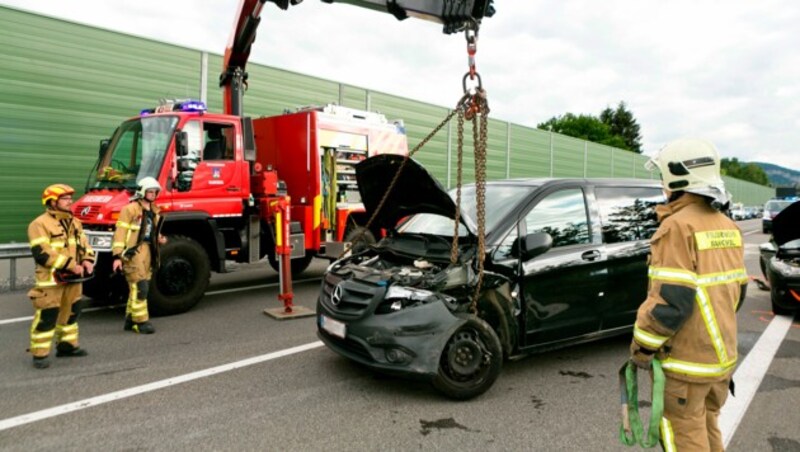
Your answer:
[339,25,489,314]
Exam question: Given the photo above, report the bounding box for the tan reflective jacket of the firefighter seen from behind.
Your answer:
[631,193,748,382]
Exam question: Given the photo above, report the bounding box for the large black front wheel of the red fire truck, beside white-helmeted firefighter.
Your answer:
[147,236,211,316]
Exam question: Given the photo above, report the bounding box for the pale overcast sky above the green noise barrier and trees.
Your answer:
[0,0,800,170]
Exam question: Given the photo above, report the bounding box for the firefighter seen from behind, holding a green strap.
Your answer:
[631,139,747,451]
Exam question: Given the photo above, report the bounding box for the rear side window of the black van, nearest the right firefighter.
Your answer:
[595,187,666,243]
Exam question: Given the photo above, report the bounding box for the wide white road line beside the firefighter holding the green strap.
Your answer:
[719,315,794,448]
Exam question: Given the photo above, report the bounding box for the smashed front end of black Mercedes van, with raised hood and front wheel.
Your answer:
[317,156,520,399]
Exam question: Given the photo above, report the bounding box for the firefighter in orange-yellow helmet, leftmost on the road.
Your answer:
[28,184,95,369]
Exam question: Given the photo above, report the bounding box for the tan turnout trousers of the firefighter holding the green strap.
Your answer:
[661,376,730,452]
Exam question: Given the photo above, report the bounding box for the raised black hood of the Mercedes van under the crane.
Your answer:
[356,154,456,233]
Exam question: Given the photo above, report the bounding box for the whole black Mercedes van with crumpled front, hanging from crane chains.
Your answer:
[317,154,665,399]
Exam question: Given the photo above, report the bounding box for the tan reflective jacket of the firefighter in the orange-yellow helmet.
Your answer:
[28,209,95,288]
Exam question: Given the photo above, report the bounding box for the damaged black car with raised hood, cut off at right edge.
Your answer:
[760,202,800,314]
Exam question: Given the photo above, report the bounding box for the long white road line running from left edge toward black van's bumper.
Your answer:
[0,341,322,431]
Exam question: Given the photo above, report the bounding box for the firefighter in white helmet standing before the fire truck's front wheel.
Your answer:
[111,177,167,334]
